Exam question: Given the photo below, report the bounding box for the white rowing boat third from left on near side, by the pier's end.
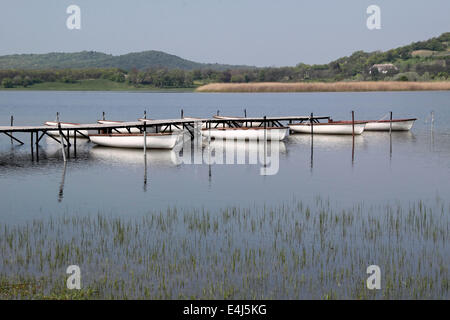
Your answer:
[289,121,366,135]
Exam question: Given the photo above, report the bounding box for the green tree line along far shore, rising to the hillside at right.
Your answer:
[0,33,450,88]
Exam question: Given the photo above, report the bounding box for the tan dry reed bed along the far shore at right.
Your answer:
[196,81,450,92]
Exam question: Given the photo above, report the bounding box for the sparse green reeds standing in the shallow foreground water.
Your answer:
[0,197,450,299]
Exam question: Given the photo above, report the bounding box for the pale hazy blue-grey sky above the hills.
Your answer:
[0,0,450,66]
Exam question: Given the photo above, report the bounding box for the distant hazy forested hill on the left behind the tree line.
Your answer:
[0,51,249,70]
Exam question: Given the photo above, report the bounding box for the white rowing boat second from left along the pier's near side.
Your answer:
[202,127,289,141]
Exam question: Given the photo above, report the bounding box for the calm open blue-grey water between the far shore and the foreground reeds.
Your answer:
[0,91,450,222]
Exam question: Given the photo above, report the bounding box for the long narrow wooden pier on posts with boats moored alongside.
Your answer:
[0,111,330,161]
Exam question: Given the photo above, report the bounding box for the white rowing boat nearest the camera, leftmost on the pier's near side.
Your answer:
[89,133,178,149]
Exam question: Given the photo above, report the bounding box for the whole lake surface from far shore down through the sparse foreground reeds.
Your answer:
[0,91,450,298]
